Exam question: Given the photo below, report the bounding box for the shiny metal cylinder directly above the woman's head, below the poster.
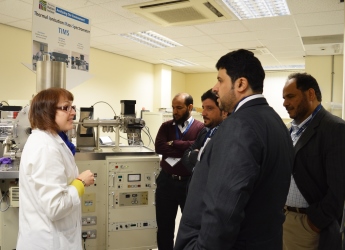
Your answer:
[36,61,66,93]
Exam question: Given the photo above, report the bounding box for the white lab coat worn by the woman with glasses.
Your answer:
[16,129,82,250]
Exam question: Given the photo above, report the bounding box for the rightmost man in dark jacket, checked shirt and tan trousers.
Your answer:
[283,73,345,250]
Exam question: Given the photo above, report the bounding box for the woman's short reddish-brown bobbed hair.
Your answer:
[29,88,74,134]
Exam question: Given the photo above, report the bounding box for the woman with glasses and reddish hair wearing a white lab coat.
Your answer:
[16,88,95,250]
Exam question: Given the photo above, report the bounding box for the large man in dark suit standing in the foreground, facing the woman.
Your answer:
[175,49,293,250]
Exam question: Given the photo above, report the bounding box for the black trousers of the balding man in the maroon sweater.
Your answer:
[156,170,188,250]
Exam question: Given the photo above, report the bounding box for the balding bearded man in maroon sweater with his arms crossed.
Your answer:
[155,93,204,250]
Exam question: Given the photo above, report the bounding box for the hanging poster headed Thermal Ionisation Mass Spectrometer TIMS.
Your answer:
[32,0,91,72]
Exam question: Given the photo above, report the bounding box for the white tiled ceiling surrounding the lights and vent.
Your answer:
[0,0,344,73]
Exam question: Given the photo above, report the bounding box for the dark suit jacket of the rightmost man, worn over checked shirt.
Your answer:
[293,108,345,250]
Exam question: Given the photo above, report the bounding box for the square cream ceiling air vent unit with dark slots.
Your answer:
[124,0,232,26]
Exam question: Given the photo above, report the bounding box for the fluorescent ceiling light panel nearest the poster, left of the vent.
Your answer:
[120,31,182,48]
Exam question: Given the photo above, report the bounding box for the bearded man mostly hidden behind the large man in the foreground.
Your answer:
[181,89,228,172]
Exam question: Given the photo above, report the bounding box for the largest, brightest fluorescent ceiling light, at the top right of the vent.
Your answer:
[222,0,290,20]
